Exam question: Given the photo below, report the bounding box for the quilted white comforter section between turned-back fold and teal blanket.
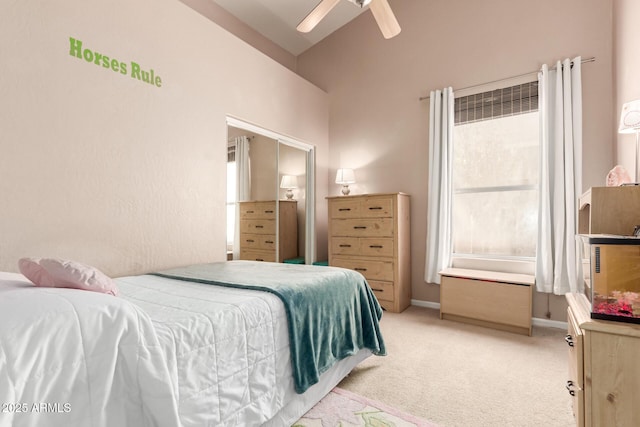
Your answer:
[117,276,295,427]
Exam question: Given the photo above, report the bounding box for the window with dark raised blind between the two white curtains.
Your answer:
[452,82,539,259]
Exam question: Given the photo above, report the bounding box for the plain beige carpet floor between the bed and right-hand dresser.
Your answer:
[339,306,575,427]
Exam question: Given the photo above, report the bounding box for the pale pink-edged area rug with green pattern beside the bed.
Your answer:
[293,387,436,427]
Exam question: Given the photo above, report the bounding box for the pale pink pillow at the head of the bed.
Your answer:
[18,258,118,295]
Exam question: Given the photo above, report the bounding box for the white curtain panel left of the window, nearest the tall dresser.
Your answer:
[424,87,454,284]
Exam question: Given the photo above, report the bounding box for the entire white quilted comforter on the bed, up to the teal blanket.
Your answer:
[0,273,302,427]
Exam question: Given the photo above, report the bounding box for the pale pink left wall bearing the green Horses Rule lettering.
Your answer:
[0,0,329,276]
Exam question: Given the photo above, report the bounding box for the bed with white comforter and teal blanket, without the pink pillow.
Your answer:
[0,261,385,427]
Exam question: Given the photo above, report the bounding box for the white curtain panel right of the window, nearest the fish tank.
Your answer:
[536,57,584,295]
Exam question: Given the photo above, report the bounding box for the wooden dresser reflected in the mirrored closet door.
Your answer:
[239,200,298,262]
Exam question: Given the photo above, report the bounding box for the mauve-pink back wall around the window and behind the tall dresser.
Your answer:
[298,0,612,320]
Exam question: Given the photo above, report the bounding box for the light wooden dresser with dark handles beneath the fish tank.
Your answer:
[566,294,640,427]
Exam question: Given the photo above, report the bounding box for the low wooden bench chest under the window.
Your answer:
[439,268,535,336]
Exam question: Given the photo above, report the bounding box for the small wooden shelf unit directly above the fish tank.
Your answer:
[578,185,640,236]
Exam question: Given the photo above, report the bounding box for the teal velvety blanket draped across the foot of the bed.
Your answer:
[152,261,386,393]
